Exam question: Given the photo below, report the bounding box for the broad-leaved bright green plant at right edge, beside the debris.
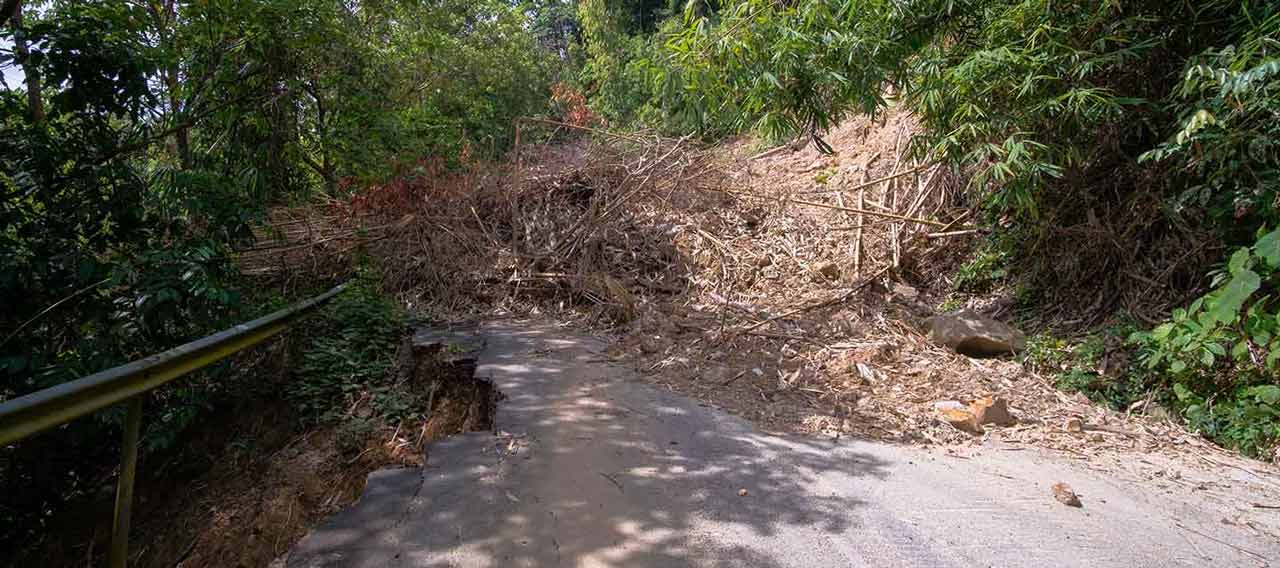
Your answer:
[1130,229,1280,455]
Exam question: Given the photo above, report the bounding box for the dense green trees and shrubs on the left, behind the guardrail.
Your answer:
[0,0,564,549]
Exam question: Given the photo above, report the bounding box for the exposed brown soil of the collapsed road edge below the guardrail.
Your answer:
[20,332,497,568]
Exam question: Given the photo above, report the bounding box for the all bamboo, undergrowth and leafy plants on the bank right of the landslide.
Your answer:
[570,0,1280,457]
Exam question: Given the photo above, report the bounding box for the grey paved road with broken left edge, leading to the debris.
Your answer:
[288,324,1280,568]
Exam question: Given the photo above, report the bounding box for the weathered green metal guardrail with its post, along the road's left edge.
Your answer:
[0,284,347,568]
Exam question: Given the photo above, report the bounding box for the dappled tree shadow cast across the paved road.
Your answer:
[289,325,887,567]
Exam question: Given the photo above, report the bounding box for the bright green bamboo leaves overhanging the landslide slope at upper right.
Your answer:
[619,0,1277,217]
